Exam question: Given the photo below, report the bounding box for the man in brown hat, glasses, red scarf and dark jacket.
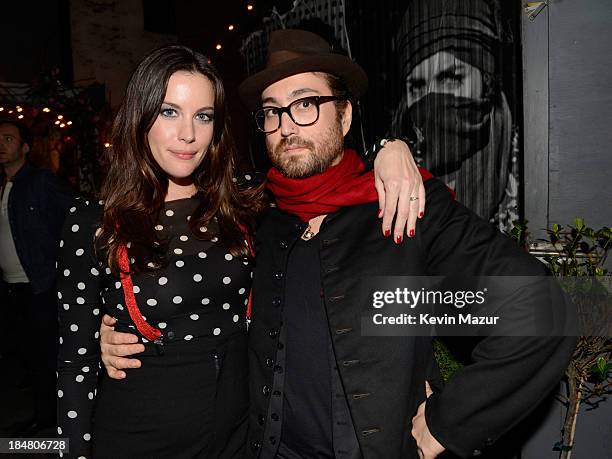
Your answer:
[103,30,574,459]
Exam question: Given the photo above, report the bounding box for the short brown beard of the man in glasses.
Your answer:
[268,122,344,178]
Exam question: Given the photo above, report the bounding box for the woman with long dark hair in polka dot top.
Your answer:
[58,46,414,458]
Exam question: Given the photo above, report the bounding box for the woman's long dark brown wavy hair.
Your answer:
[96,45,263,274]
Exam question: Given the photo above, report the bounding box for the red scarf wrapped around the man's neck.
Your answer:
[267,148,433,222]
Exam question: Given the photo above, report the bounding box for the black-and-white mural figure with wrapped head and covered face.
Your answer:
[392,0,518,229]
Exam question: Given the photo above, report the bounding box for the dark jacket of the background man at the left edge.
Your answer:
[1,163,76,293]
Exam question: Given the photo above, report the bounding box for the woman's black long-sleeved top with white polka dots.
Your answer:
[58,198,252,457]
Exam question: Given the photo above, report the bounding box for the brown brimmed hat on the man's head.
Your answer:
[238,29,368,110]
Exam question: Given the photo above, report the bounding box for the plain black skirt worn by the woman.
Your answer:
[93,333,248,459]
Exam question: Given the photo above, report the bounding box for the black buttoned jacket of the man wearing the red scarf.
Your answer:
[247,180,575,458]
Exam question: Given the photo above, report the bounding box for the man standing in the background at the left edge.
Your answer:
[0,119,74,435]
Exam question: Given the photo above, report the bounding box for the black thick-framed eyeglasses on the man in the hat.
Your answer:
[253,96,344,134]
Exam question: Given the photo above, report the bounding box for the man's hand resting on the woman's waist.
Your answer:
[100,314,144,379]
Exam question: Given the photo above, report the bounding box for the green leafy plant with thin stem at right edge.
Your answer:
[510,218,612,459]
